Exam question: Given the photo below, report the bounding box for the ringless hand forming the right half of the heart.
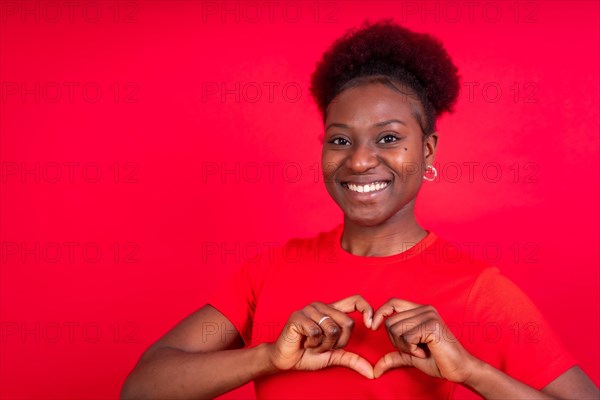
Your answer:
[371,299,480,383]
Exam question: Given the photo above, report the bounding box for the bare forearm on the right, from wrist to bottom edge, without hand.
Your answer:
[464,362,554,400]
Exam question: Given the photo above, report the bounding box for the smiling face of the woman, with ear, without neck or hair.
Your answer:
[322,83,437,226]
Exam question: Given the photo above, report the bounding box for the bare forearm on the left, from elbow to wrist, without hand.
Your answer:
[121,344,274,399]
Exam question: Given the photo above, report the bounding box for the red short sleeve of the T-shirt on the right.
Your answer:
[461,267,576,390]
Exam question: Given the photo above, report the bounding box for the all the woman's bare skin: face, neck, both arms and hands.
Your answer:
[121,79,598,399]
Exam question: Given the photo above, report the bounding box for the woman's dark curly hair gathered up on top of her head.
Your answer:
[310,19,460,136]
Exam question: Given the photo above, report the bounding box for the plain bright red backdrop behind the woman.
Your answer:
[0,1,600,399]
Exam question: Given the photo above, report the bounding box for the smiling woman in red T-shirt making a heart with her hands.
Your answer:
[122,21,598,399]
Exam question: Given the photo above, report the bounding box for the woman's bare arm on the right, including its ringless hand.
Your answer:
[372,299,598,399]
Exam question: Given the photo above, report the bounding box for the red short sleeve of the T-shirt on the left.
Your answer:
[208,262,260,346]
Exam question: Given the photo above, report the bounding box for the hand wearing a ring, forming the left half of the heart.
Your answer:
[269,295,373,379]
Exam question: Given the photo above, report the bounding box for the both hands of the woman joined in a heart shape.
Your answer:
[269,295,479,383]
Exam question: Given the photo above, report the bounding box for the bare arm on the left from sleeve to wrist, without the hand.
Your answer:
[121,305,271,399]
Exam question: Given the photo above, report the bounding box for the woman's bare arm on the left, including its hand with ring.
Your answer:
[121,296,373,399]
